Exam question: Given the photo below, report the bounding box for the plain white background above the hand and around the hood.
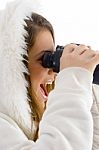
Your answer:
[0,0,99,50]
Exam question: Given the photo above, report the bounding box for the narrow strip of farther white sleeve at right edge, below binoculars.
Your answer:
[91,84,99,150]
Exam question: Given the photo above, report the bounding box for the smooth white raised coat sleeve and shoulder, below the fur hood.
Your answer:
[0,67,93,150]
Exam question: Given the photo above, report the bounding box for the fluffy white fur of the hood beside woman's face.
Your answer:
[0,0,41,138]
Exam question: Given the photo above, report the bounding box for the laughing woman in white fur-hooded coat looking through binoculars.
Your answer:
[0,0,99,150]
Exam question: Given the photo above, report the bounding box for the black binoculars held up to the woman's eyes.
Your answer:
[42,44,99,85]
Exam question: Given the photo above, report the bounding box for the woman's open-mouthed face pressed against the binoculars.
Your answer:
[29,30,54,102]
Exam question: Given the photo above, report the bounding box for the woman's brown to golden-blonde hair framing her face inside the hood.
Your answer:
[24,13,55,141]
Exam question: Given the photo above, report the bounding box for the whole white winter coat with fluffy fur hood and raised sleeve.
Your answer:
[0,0,99,150]
